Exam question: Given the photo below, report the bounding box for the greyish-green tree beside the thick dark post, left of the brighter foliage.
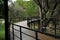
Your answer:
[8,1,25,22]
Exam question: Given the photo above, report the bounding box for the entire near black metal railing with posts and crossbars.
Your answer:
[9,24,60,40]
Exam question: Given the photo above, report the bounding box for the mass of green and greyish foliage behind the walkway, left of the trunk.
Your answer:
[9,0,39,22]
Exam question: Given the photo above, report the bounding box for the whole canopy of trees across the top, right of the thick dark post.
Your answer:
[9,0,60,22]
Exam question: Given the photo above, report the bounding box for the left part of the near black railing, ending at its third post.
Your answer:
[12,24,39,40]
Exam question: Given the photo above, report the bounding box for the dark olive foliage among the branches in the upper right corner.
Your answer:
[34,0,60,17]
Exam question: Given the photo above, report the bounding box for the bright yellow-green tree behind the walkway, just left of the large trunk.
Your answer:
[17,0,39,17]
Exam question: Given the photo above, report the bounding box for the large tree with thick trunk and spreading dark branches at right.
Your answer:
[34,0,60,27]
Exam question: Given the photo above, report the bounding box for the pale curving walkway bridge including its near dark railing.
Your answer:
[10,20,60,40]
